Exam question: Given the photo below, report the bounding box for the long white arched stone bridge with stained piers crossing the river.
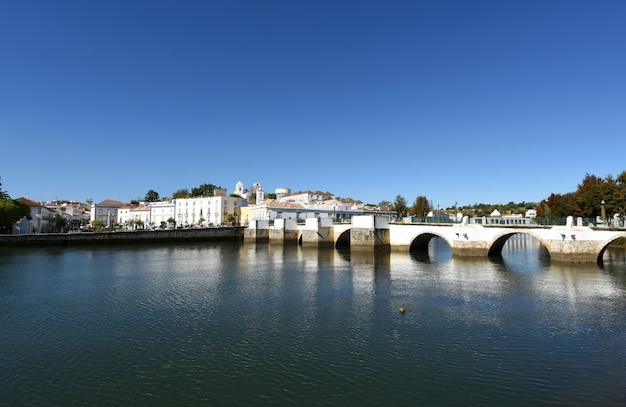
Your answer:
[244,215,626,263]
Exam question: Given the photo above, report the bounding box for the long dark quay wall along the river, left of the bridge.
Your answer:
[0,227,244,246]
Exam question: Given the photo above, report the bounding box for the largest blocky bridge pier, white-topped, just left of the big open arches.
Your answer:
[350,215,391,252]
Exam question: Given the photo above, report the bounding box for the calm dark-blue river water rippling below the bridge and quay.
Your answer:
[0,238,626,406]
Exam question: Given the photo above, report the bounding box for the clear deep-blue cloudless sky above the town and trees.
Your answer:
[0,0,626,207]
